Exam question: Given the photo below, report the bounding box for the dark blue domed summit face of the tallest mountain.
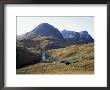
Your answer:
[32,23,63,40]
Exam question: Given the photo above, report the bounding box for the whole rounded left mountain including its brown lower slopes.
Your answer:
[17,23,65,49]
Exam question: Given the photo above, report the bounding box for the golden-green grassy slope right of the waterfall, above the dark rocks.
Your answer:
[49,43,94,62]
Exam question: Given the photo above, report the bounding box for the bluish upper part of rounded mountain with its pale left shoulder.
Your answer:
[17,23,64,40]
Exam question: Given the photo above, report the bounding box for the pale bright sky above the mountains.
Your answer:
[17,16,94,38]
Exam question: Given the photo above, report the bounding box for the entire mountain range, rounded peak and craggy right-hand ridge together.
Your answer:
[17,23,94,50]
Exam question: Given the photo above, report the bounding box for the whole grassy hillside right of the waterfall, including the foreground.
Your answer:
[16,43,94,74]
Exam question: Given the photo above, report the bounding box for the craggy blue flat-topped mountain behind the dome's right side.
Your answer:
[61,30,94,44]
